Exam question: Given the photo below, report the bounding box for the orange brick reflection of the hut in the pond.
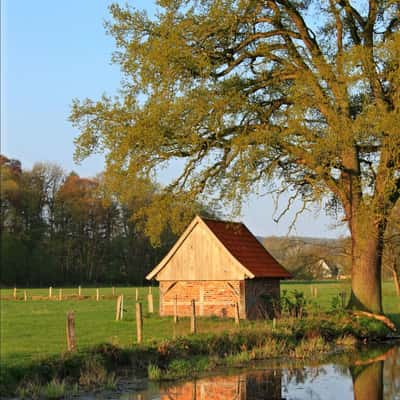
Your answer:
[160,370,283,400]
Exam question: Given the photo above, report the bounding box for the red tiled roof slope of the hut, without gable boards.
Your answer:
[202,218,292,278]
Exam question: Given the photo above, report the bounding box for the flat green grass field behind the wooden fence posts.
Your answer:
[0,282,400,367]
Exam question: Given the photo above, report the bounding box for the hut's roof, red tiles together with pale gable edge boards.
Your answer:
[146,216,292,279]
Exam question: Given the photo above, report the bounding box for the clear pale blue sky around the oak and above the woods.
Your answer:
[1,0,346,237]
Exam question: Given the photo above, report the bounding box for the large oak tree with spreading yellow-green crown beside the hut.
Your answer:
[71,0,400,313]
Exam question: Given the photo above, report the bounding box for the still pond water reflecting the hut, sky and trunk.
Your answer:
[86,344,400,400]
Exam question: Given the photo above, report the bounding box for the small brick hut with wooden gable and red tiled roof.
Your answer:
[146,217,291,318]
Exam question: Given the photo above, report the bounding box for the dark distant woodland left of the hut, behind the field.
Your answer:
[0,156,176,287]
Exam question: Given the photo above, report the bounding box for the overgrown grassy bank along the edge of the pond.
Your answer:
[0,313,396,398]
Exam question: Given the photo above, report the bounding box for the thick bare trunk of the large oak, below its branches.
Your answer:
[349,224,383,314]
